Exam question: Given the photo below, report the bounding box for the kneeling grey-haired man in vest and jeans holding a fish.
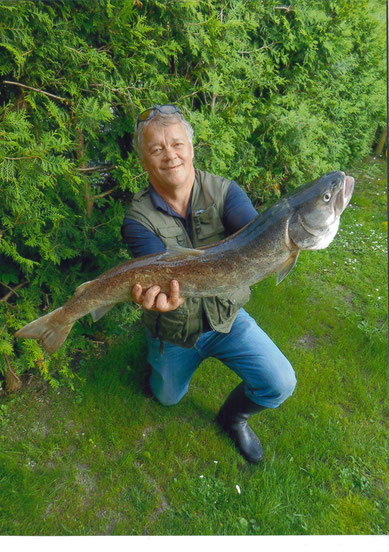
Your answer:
[122,105,296,463]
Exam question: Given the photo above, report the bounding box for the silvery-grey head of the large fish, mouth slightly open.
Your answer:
[288,171,354,249]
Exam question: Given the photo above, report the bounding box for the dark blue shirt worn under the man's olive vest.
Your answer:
[121,181,257,257]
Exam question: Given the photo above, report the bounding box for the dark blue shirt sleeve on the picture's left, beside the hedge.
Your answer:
[121,218,166,257]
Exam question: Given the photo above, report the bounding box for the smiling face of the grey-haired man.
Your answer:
[141,123,194,191]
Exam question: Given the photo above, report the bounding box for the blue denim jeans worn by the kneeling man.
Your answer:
[146,309,296,408]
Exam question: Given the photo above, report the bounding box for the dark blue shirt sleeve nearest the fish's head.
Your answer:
[223,180,258,234]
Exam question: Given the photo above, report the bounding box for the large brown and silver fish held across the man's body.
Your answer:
[15,172,354,353]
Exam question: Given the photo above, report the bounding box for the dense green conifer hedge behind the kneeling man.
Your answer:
[0,0,385,388]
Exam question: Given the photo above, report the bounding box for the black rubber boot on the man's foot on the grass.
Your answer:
[216,382,266,464]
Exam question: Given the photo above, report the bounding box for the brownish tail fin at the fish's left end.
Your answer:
[15,307,74,353]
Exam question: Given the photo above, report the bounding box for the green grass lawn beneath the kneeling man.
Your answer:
[0,155,388,535]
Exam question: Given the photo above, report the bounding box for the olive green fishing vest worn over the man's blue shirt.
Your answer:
[126,169,251,349]
